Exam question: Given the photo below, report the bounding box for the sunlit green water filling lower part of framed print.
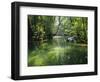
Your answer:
[28,43,87,66]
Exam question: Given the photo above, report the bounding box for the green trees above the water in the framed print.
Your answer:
[27,15,88,66]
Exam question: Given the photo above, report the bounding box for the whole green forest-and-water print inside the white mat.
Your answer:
[28,15,88,66]
